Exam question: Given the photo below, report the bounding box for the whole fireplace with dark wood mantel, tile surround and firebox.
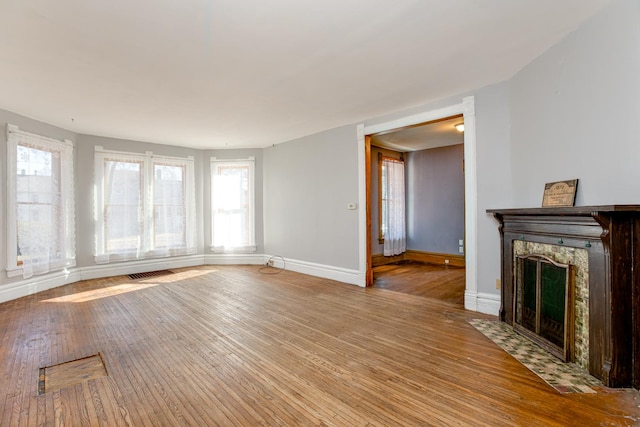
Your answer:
[487,205,640,388]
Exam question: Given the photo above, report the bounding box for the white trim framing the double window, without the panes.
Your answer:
[93,145,197,264]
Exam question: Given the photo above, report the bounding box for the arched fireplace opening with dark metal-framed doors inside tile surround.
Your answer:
[513,254,575,362]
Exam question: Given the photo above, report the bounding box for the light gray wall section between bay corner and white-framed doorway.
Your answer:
[264,125,364,270]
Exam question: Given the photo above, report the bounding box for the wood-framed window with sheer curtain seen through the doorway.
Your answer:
[378,153,406,256]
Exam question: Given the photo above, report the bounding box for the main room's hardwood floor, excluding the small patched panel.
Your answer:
[0,266,640,426]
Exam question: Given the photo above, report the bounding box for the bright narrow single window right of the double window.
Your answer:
[211,157,256,253]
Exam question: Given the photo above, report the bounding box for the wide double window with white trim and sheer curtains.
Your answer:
[96,147,196,263]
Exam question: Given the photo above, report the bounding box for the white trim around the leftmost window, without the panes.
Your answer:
[6,123,76,277]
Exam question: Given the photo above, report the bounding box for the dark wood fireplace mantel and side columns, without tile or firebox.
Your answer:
[487,205,640,388]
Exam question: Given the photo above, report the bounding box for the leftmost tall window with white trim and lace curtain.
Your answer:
[7,124,75,278]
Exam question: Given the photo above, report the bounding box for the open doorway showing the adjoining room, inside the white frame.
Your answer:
[368,114,465,306]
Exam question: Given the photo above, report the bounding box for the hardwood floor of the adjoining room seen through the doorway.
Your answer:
[373,262,465,307]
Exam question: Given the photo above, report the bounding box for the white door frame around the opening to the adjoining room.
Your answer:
[358,96,478,311]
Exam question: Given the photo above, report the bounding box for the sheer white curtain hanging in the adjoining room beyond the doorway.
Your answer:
[381,159,407,256]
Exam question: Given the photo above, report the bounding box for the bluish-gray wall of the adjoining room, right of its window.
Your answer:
[405,144,464,254]
